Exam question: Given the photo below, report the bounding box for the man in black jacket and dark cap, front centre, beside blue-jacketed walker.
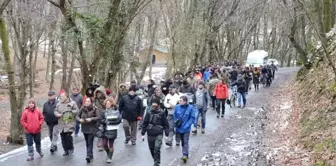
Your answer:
[141,98,169,166]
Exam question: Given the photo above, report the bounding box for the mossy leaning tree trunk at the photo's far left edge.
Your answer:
[0,17,23,144]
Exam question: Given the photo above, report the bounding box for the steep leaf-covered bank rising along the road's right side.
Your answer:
[293,36,336,166]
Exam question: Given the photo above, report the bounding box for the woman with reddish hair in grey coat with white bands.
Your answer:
[100,98,122,163]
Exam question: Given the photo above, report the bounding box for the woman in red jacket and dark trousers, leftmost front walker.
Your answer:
[20,99,44,161]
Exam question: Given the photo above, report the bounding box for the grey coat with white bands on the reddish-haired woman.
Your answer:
[99,107,122,139]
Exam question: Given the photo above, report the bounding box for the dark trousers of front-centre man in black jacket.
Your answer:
[147,135,163,166]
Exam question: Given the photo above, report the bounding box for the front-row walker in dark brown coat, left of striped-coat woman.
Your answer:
[76,98,100,163]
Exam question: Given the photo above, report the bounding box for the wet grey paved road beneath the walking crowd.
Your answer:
[0,68,297,166]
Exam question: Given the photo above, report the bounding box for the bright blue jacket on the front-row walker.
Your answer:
[174,104,196,133]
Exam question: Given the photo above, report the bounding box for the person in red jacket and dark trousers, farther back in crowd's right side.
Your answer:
[213,79,229,118]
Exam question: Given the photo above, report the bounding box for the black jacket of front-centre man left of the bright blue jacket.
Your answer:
[141,109,169,136]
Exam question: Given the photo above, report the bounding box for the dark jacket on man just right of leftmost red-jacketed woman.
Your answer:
[42,99,58,125]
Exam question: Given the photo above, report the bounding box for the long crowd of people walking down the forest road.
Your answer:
[21,62,277,166]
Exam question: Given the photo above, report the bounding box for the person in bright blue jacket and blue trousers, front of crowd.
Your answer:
[174,96,196,163]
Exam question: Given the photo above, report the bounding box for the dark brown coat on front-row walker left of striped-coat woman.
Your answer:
[76,106,100,134]
